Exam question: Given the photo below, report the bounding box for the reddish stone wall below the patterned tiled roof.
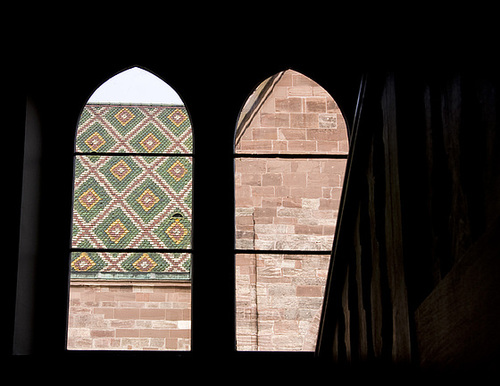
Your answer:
[67,280,191,350]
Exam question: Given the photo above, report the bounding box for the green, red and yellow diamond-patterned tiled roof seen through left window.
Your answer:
[71,104,193,279]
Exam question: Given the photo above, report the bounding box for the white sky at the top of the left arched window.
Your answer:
[87,67,184,105]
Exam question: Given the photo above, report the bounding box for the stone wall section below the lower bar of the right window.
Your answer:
[236,254,330,351]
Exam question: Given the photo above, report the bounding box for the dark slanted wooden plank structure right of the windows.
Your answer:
[319,70,500,369]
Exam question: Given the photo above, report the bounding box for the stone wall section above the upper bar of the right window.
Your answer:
[235,70,349,154]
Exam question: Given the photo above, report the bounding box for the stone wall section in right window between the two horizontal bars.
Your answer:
[235,158,346,251]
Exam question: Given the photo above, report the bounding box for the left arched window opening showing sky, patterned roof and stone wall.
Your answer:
[67,67,193,350]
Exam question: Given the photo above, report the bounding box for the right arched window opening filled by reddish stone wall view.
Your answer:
[234,70,349,351]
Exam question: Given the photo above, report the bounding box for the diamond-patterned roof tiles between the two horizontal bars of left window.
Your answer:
[72,155,192,249]
